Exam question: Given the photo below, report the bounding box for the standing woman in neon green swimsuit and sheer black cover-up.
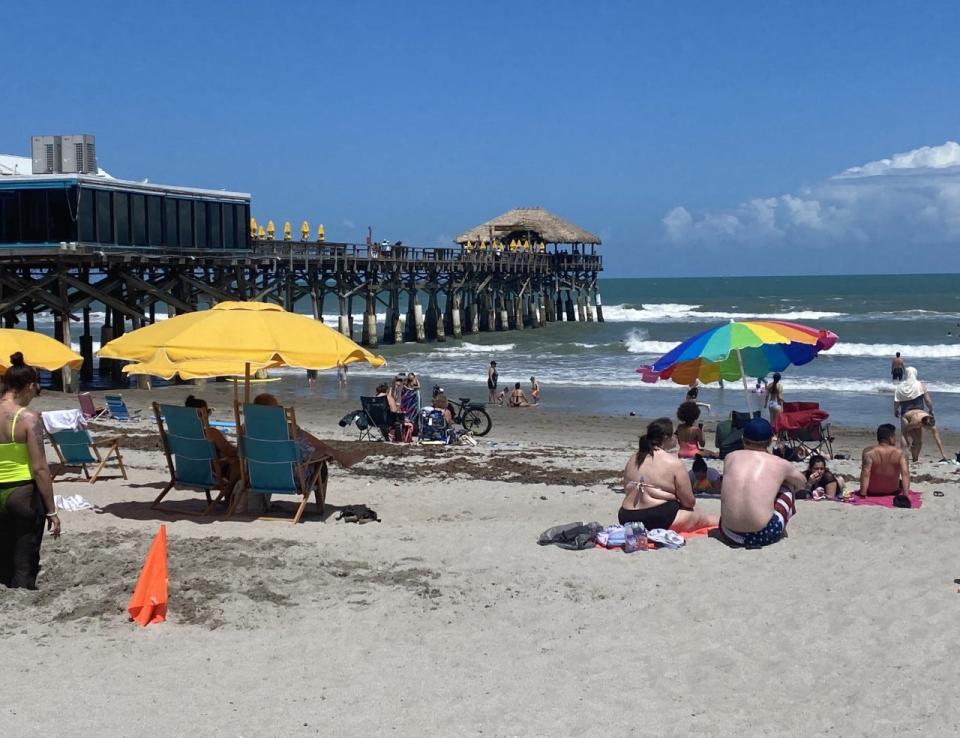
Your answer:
[0,352,60,589]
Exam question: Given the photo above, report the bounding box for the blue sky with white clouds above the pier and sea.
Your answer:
[0,0,960,277]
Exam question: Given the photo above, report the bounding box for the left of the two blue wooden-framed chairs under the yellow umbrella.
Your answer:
[152,402,236,515]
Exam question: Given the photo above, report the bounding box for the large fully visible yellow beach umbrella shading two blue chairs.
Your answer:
[99,302,386,390]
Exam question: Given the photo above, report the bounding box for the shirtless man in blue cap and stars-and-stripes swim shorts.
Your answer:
[720,418,806,548]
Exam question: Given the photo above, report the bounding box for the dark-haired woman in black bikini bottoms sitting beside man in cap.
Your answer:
[618,418,717,532]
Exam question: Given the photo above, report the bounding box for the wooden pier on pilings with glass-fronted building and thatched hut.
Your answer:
[0,137,603,388]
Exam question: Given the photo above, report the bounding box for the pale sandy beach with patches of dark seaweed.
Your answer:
[0,384,960,736]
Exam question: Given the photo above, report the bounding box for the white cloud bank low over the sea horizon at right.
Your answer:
[662,141,960,246]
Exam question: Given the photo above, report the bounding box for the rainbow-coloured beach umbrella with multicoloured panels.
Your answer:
[637,320,837,387]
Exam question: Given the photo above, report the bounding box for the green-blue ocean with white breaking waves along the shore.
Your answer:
[38,274,960,429]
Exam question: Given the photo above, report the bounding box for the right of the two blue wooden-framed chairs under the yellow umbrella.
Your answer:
[227,405,329,523]
